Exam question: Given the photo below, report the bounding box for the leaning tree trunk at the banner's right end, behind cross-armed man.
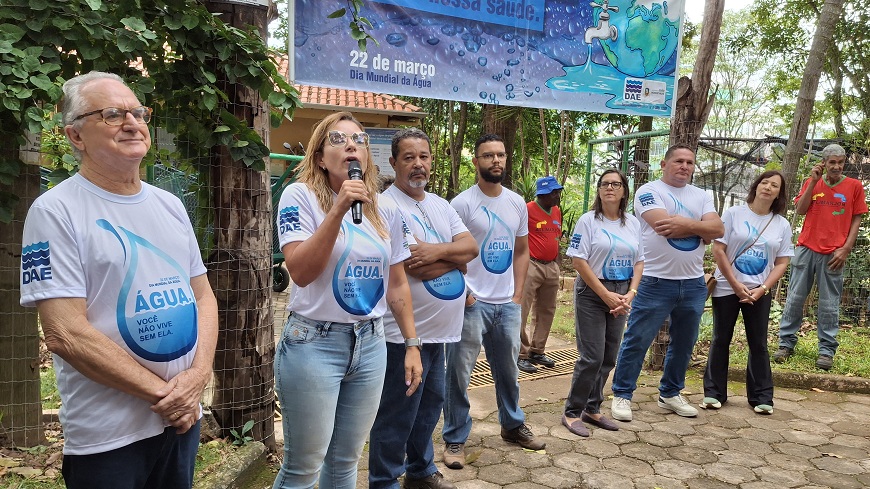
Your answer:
[648,0,725,370]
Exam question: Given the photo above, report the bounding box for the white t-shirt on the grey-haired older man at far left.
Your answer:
[21,174,206,455]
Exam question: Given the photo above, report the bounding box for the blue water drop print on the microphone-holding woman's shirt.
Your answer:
[332,222,388,316]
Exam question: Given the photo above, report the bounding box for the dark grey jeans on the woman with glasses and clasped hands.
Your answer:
[565,277,629,418]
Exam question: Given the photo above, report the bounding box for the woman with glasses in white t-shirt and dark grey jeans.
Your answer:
[562,169,643,437]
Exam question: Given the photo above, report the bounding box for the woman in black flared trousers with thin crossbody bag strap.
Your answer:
[701,170,794,414]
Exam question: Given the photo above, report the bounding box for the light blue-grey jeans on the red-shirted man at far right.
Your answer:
[779,246,845,357]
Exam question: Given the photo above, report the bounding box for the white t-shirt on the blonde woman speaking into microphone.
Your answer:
[277,182,411,323]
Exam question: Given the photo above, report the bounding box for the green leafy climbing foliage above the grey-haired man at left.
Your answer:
[0,0,304,220]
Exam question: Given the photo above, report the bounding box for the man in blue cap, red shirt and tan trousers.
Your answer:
[517,175,562,373]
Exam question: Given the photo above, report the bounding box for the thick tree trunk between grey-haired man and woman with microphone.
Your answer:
[206,2,275,451]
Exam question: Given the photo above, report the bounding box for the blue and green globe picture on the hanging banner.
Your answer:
[594,0,681,77]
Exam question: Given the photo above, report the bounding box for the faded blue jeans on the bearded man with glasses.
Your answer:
[443,301,526,443]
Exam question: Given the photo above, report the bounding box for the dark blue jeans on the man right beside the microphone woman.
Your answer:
[369,343,445,489]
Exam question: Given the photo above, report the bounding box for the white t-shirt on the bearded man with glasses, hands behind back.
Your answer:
[450,185,529,304]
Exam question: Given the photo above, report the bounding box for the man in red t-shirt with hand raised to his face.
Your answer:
[773,144,867,370]
